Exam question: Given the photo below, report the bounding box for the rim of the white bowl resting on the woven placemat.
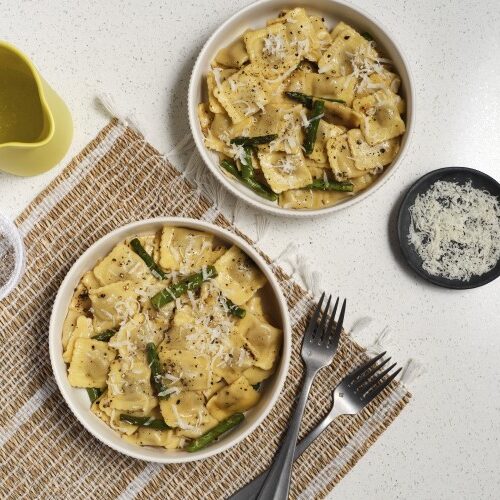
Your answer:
[49,217,292,464]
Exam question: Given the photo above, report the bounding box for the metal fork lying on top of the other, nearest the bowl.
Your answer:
[258,293,346,500]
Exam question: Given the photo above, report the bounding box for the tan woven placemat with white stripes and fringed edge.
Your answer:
[0,120,410,500]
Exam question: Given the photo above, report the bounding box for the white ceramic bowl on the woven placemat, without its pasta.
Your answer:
[49,217,291,463]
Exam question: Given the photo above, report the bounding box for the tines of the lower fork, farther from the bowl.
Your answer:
[349,352,402,402]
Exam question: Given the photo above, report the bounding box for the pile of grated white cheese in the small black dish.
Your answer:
[408,181,500,281]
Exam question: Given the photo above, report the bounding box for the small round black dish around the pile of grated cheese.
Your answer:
[398,167,500,290]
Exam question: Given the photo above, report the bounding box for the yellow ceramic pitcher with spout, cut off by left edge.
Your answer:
[0,40,73,176]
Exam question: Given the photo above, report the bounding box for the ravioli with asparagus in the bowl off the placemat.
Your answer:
[198,7,406,210]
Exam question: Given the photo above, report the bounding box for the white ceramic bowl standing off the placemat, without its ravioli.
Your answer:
[188,0,414,217]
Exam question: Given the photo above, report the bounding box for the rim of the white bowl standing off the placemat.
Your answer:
[187,0,415,218]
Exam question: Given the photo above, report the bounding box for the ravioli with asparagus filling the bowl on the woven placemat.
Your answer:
[61,226,283,451]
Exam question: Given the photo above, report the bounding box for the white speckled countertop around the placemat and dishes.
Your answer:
[0,0,500,500]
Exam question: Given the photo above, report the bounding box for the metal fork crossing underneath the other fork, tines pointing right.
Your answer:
[229,352,401,500]
